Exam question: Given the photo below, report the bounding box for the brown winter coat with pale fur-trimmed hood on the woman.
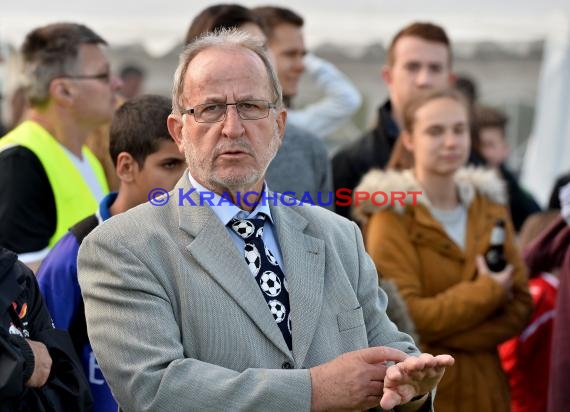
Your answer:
[354,169,532,412]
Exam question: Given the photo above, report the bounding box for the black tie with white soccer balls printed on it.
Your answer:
[229,213,293,350]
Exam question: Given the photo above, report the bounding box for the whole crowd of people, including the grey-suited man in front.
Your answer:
[0,4,570,412]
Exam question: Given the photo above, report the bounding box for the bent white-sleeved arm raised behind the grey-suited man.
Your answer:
[288,55,362,139]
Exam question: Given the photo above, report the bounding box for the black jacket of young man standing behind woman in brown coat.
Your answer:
[332,100,400,219]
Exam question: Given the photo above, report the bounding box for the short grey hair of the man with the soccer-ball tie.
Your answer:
[172,29,283,113]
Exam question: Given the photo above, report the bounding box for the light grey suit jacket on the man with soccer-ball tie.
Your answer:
[78,174,418,412]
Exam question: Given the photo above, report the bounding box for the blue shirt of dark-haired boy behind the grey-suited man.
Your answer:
[37,193,118,412]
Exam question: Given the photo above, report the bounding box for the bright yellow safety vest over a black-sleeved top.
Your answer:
[0,121,109,248]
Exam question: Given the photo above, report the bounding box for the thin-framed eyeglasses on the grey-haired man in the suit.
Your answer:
[181,100,276,123]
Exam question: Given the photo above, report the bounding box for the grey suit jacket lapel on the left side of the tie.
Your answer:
[174,174,291,357]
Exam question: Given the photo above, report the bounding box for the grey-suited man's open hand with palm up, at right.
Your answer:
[380,353,455,409]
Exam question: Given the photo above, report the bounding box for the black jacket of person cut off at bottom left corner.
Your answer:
[0,247,92,412]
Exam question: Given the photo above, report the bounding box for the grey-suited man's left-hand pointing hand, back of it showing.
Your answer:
[310,346,409,411]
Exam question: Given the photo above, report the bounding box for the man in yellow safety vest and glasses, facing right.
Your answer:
[0,23,121,266]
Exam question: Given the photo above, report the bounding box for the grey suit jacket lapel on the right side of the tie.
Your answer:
[271,206,325,365]
